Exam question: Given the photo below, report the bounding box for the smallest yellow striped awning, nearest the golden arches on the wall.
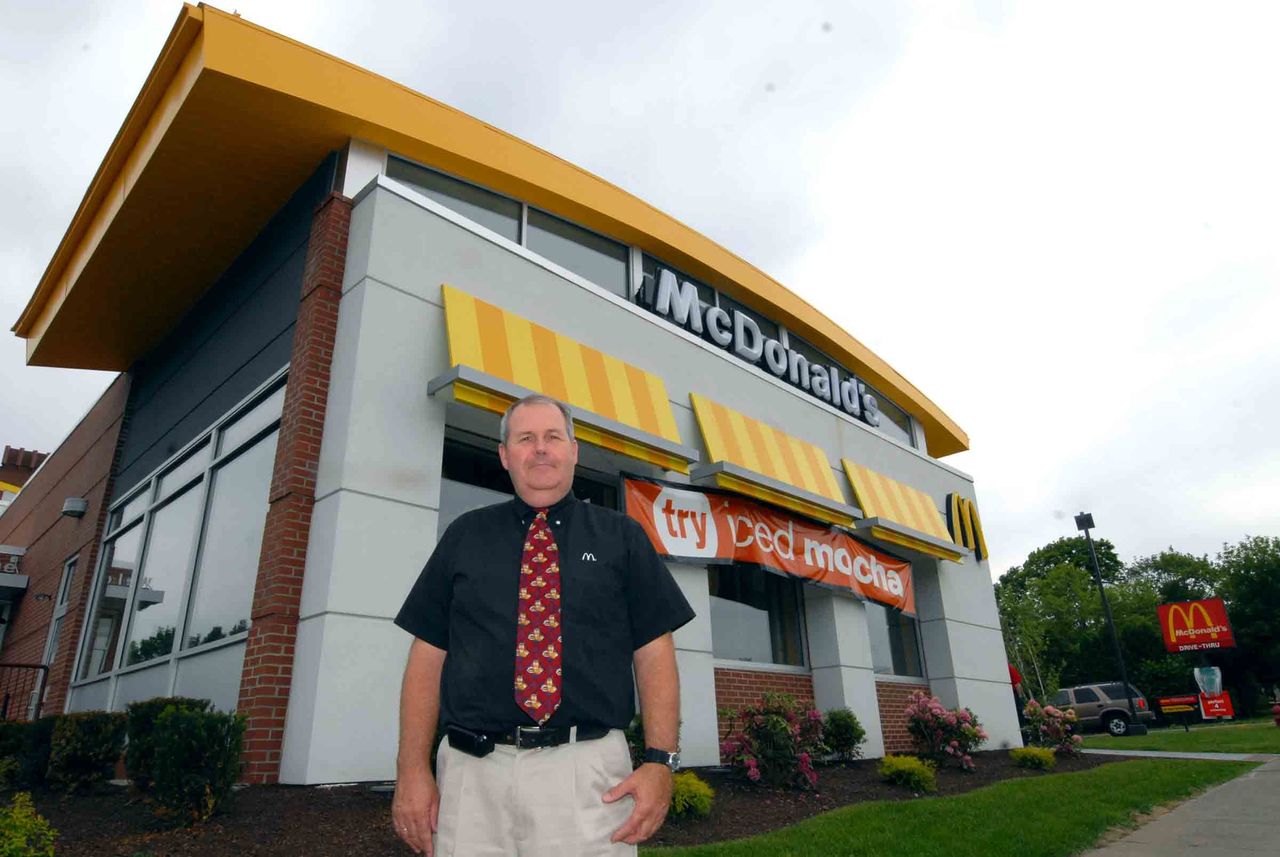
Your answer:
[841,458,964,562]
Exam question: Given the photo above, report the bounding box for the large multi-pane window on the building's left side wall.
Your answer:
[77,380,284,680]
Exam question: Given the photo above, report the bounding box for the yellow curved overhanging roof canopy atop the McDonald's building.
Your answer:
[14,5,969,457]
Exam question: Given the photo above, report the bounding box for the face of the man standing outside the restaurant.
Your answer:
[498,404,577,507]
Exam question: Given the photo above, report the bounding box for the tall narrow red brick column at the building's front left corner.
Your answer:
[237,193,352,783]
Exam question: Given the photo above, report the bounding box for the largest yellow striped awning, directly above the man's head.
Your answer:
[428,285,698,473]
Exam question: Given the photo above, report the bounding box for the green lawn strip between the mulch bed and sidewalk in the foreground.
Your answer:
[645,762,1254,857]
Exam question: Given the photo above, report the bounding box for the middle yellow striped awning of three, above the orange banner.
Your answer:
[689,393,856,527]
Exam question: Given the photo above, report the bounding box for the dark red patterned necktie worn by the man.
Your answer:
[516,509,561,725]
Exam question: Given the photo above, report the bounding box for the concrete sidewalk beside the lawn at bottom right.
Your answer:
[1084,750,1280,857]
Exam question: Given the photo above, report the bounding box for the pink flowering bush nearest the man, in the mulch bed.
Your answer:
[721,693,827,788]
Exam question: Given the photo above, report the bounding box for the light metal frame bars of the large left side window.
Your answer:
[69,365,289,702]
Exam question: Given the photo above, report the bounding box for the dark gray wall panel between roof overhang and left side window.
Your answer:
[113,155,337,500]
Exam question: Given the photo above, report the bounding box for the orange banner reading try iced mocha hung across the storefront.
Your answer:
[622,478,915,615]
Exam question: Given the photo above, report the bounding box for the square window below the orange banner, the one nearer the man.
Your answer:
[708,565,804,666]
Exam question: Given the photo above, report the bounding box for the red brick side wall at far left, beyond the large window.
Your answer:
[0,375,129,716]
